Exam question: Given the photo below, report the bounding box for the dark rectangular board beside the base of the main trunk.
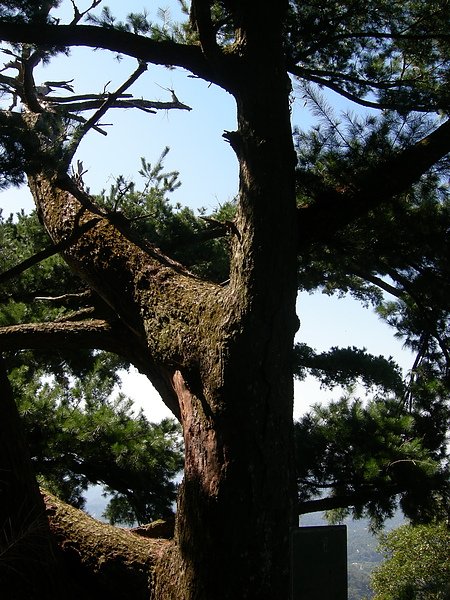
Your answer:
[291,525,347,600]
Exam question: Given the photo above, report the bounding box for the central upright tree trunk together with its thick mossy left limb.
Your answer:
[22,1,297,600]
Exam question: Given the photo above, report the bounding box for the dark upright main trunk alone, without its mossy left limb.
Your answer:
[156,4,298,600]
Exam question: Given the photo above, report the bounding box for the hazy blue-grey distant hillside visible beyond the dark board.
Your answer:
[300,512,404,600]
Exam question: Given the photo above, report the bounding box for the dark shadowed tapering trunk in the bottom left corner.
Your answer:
[0,355,57,600]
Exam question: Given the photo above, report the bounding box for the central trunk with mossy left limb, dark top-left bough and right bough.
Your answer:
[0,0,449,600]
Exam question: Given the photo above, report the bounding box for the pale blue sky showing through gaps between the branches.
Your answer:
[0,0,412,421]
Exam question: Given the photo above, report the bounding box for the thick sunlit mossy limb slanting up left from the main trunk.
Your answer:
[30,177,225,376]
